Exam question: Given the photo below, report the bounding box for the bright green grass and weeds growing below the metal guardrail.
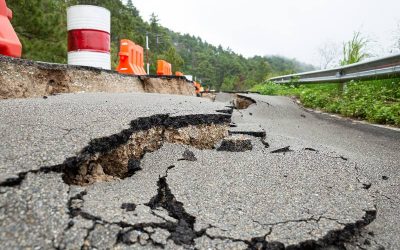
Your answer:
[251,79,400,127]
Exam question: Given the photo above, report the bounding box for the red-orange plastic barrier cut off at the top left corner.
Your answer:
[0,0,22,57]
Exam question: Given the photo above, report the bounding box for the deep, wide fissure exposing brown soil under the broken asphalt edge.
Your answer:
[64,114,230,186]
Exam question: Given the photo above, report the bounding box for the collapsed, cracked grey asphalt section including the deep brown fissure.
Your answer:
[0,93,377,249]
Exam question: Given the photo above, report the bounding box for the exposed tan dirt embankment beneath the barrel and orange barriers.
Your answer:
[0,56,195,99]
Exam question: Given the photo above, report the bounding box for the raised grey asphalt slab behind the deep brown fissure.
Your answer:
[0,93,227,182]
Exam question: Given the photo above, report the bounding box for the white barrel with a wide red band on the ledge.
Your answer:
[67,5,111,69]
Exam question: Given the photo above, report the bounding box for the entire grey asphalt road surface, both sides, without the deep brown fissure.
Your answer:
[0,94,400,249]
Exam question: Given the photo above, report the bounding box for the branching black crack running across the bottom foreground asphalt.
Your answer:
[65,161,376,250]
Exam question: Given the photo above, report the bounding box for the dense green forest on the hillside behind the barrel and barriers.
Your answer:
[7,0,313,90]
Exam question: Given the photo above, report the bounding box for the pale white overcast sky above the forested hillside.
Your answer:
[132,0,400,66]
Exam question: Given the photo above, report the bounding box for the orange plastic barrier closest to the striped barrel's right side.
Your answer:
[117,39,147,75]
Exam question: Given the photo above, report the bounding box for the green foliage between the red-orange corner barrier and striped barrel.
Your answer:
[7,0,67,63]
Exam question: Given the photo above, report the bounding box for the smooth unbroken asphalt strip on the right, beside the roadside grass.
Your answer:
[234,94,400,249]
